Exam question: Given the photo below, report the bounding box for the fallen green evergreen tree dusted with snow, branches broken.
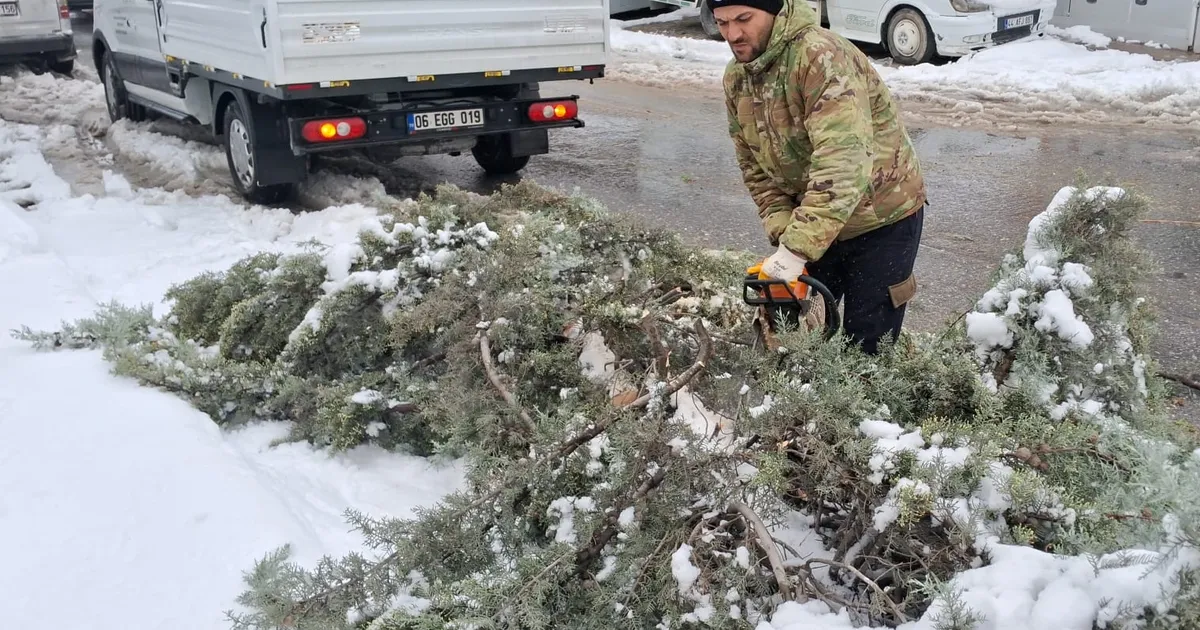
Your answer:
[19,178,1200,630]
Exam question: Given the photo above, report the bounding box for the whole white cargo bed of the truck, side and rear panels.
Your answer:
[162,0,608,85]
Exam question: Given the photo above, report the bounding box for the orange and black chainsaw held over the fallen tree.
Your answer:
[742,259,841,352]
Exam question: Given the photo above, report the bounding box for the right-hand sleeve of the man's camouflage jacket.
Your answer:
[781,36,874,260]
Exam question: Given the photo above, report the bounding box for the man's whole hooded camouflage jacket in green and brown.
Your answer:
[725,0,925,260]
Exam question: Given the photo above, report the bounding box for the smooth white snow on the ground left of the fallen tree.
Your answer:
[0,116,464,630]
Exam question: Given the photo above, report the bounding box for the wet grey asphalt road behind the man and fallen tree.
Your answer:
[63,20,1200,403]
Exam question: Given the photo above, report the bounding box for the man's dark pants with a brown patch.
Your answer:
[808,208,925,354]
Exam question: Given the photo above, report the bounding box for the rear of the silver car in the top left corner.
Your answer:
[0,0,76,74]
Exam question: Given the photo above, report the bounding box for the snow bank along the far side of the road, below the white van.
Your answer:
[610,11,1200,127]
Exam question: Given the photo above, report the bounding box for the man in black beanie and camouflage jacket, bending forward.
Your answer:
[708,0,925,354]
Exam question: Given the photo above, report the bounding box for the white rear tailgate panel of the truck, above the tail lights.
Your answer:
[270,0,608,84]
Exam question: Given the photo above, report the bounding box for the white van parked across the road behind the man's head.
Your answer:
[630,0,1057,65]
